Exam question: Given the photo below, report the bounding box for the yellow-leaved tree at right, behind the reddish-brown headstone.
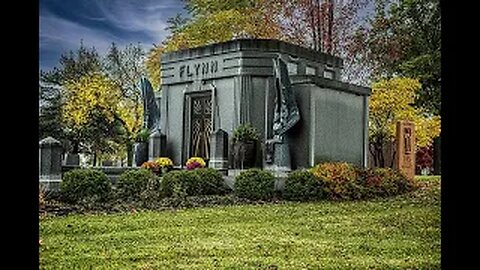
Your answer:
[369,78,440,167]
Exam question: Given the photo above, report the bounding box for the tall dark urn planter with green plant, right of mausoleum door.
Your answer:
[232,123,259,169]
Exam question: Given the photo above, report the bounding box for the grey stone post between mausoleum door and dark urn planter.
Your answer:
[208,129,228,171]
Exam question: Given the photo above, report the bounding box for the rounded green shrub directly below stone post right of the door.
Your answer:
[189,168,227,195]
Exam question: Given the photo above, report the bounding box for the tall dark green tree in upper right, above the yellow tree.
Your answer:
[349,0,441,115]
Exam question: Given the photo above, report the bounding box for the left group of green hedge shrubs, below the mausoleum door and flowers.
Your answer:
[60,168,228,203]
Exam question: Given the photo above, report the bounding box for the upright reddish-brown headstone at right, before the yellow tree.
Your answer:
[396,121,415,179]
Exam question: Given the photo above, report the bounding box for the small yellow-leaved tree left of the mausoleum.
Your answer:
[63,73,121,165]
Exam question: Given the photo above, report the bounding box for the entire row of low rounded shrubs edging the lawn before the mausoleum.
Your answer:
[60,162,415,203]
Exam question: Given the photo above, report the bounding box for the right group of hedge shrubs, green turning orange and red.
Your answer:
[235,162,416,201]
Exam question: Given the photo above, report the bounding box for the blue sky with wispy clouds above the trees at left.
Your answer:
[39,0,186,70]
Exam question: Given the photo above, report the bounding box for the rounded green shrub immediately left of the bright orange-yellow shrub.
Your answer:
[283,170,326,201]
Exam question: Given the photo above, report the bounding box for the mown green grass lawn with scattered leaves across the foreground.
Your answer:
[40,177,440,269]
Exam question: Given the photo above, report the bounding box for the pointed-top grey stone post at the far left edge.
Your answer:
[39,137,62,190]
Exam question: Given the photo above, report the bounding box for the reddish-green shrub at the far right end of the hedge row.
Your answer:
[359,168,416,198]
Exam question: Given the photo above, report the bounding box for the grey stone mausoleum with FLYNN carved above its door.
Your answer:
[157,39,371,169]
